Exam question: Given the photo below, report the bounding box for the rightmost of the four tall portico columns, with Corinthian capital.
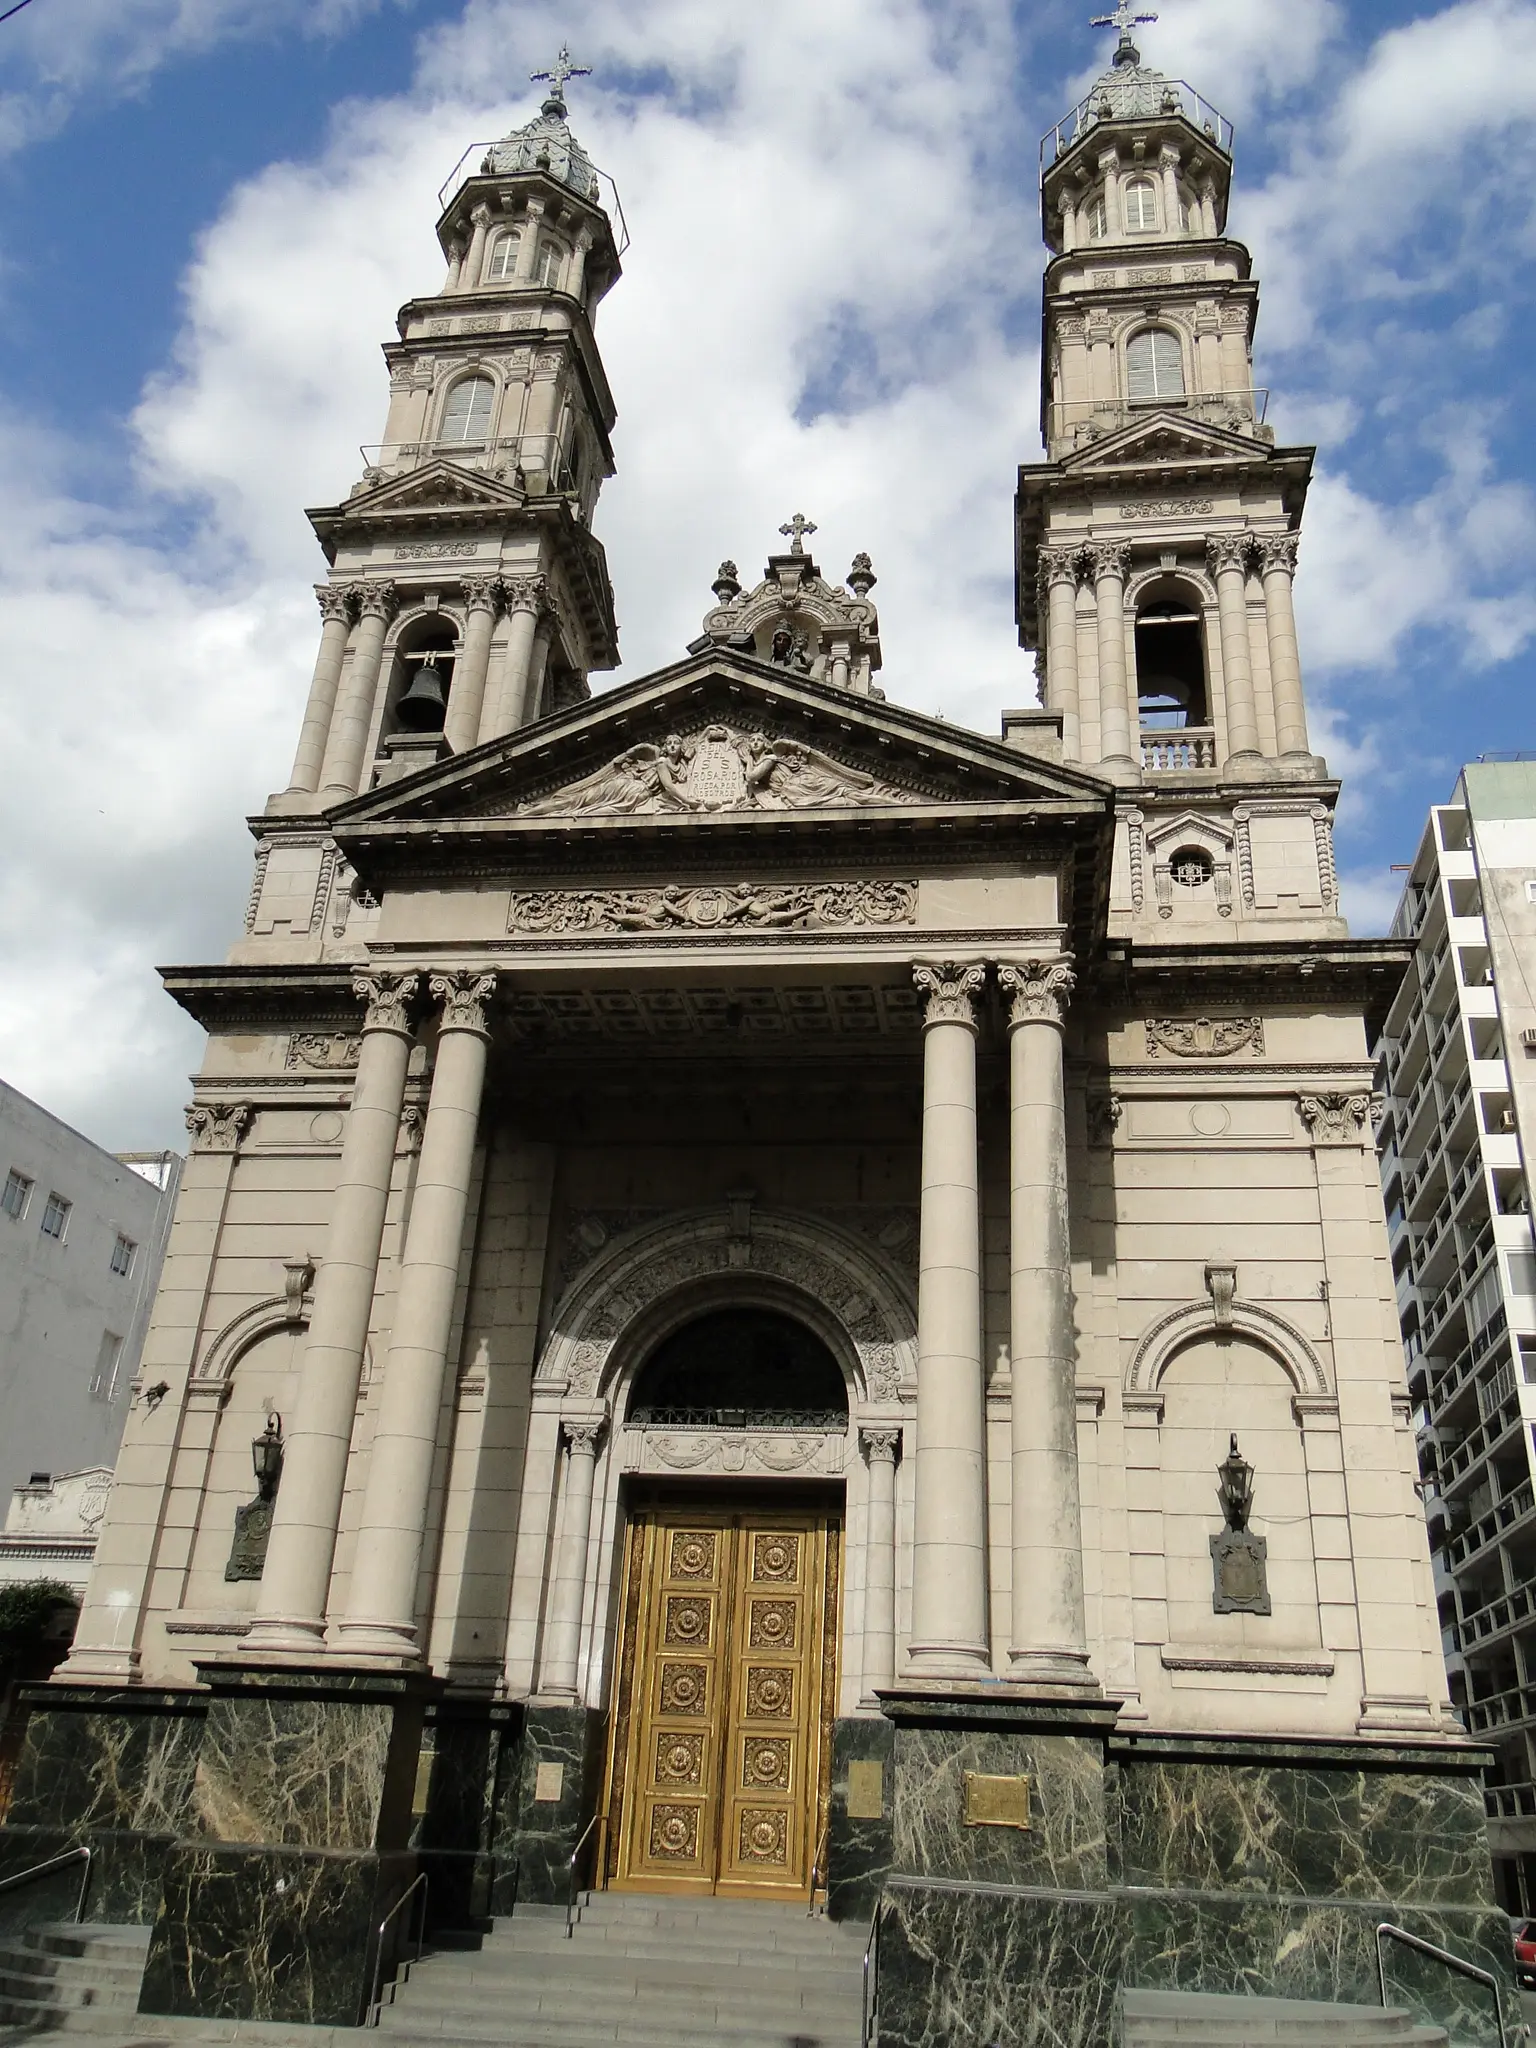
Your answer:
[997,961,1098,1692]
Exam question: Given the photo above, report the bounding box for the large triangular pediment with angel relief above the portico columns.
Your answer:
[336,651,1110,836]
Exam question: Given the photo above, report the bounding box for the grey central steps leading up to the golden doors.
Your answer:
[379,1892,864,2048]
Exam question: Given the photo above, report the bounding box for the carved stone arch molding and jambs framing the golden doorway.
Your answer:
[506,1200,918,1708]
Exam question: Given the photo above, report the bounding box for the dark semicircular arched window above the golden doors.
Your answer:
[629,1307,848,1430]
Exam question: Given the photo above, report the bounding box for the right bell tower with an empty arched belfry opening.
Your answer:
[1018,0,1337,938]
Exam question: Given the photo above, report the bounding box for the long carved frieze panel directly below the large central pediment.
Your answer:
[506,881,918,938]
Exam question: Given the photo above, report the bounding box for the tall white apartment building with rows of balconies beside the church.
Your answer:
[1376,756,1536,1913]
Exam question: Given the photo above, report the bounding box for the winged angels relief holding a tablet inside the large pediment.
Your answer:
[504,725,924,817]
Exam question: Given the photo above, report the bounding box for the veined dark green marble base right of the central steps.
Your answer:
[879,1686,1518,2048]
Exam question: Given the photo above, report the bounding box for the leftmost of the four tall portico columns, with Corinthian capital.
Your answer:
[246,975,420,1653]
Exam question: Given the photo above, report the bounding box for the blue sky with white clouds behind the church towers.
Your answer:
[0,0,1536,1149]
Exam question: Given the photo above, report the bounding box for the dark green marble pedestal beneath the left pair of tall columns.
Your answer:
[139,1663,440,2025]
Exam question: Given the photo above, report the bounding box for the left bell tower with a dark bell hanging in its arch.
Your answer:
[268,49,625,815]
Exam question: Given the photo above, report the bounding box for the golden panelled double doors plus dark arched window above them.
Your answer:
[608,1307,848,1898]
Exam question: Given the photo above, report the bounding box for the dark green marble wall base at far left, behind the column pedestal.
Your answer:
[0,1686,207,1931]
